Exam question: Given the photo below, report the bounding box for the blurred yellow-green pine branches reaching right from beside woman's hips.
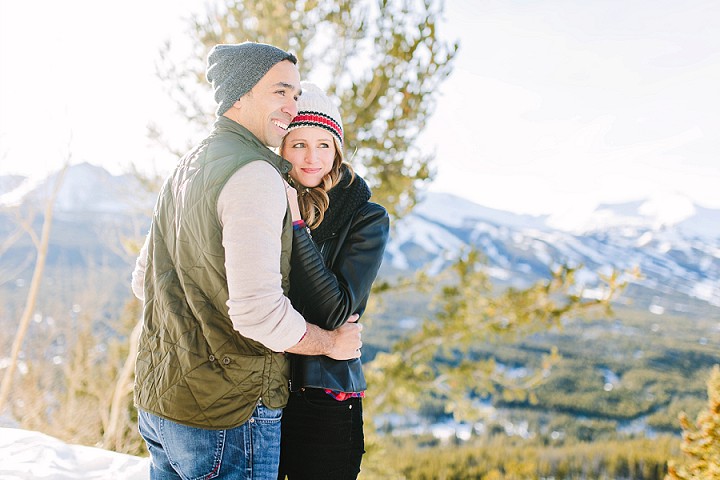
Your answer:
[366,250,626,421]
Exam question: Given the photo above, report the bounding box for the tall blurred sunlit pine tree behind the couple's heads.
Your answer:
[151,0,458,216]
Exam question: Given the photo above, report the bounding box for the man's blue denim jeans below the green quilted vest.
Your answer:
[138,403,282,480]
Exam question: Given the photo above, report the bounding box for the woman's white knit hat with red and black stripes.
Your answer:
[288,82,343,147]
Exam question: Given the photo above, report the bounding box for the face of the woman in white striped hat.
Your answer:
[280,127,335,187]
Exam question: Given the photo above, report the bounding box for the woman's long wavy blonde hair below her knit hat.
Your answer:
[280,135,355,230]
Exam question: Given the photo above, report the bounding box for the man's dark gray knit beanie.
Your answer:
[205,42,297,117]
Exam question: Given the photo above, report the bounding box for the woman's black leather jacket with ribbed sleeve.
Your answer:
[289,171,390,392]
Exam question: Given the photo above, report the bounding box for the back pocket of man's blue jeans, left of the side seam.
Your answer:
[160,420,227,480]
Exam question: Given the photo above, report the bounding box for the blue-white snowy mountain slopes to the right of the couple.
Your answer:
[385,193,720,312]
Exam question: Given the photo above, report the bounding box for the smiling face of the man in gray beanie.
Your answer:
[234,60,300,147]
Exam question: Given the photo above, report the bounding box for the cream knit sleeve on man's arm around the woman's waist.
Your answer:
[217,161,306,352]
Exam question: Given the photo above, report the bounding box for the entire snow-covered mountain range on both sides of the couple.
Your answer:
[0,164,720,312]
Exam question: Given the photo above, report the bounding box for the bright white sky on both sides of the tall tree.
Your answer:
[0,0,720,214]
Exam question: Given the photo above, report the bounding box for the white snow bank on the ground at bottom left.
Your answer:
[0,428,149,480]
